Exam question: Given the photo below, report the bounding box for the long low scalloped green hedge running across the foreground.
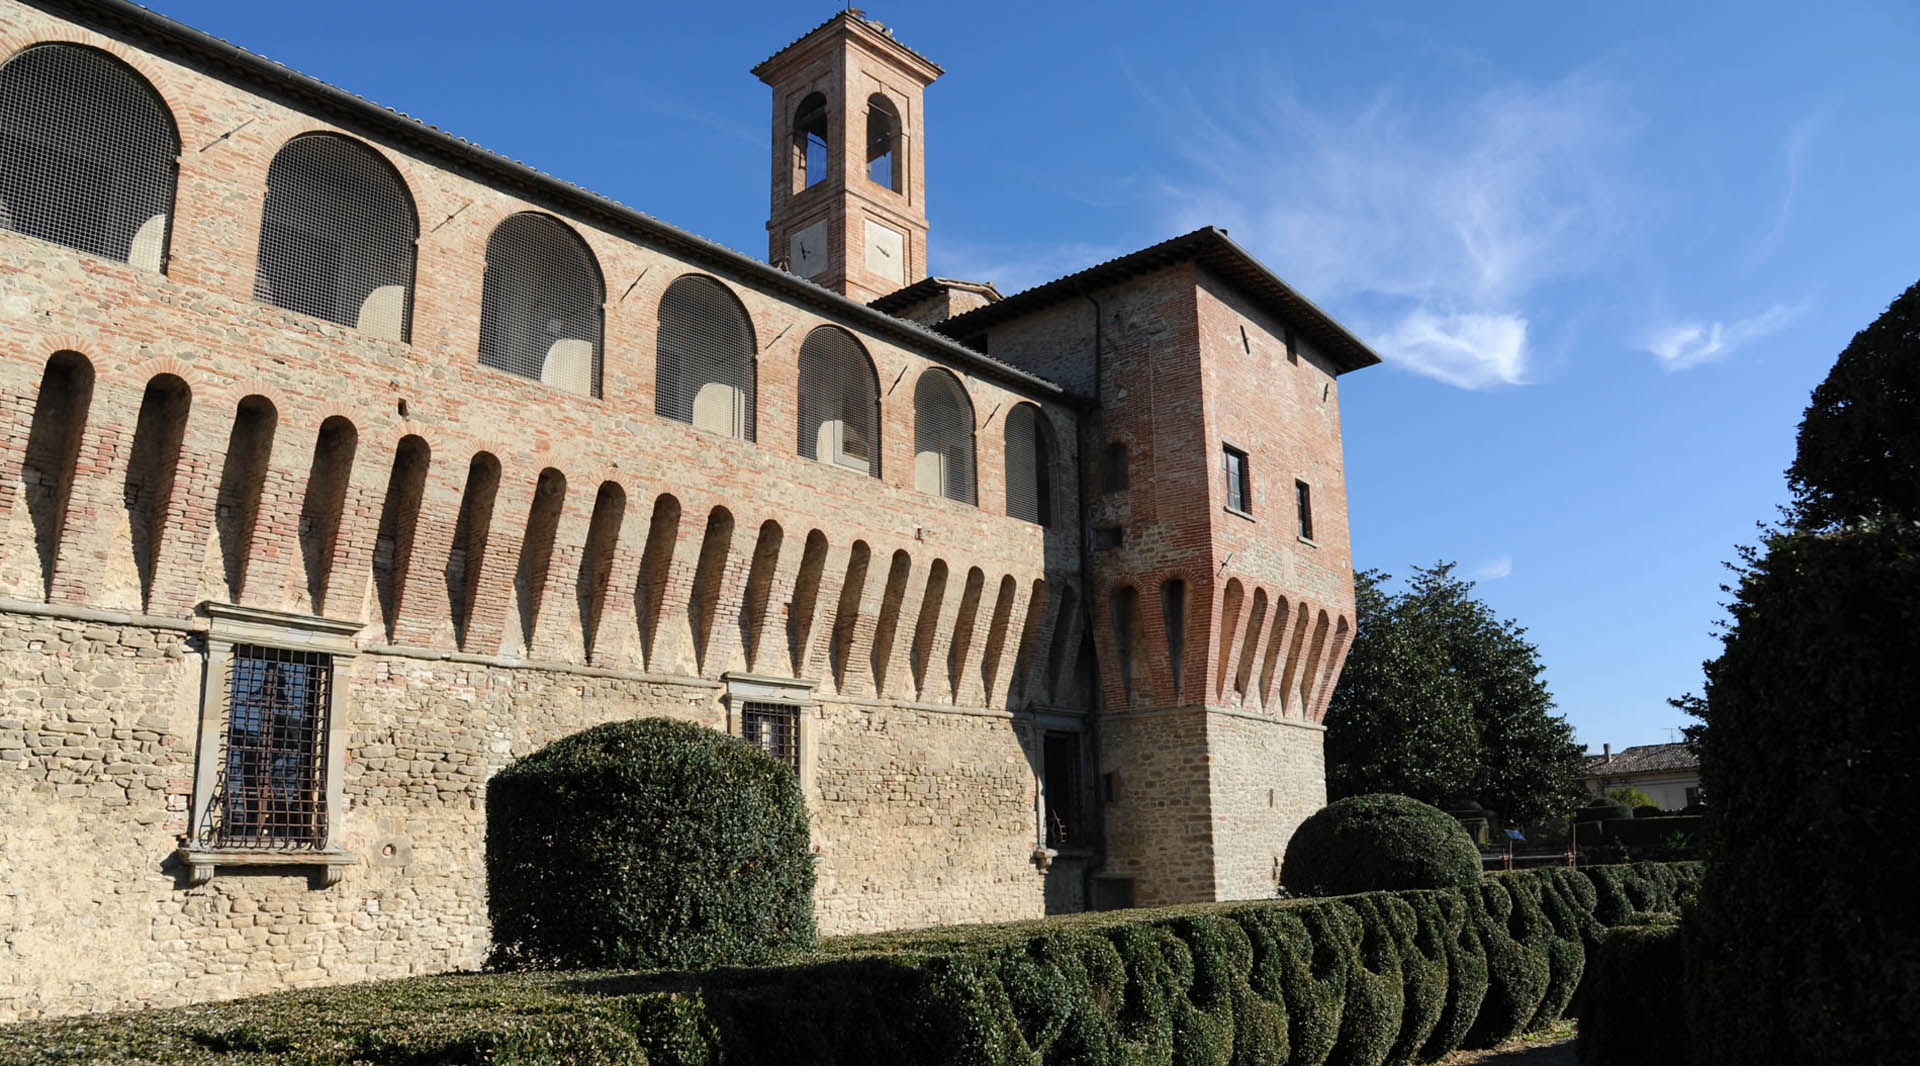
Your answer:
[0,864,1697,1066]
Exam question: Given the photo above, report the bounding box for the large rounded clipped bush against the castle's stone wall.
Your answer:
[486,718,816,968]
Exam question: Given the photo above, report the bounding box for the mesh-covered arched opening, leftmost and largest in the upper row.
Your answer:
[0,44,180,271]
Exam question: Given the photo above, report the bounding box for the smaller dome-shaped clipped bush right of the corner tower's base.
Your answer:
[1281,793,1480,895]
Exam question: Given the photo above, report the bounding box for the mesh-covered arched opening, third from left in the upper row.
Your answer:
[480,211,605,396]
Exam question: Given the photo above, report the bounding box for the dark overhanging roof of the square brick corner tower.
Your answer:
[935,227,1380,371]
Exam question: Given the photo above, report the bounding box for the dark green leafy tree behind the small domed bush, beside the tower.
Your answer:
[1327,563,1586,822]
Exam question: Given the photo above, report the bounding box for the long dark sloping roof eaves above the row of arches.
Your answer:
[52,0,1052,395]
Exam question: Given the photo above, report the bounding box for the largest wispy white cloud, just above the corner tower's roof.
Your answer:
[1135,65,1638,388]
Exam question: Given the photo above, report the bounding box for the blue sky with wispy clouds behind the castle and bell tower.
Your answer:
[154,0,1920,749]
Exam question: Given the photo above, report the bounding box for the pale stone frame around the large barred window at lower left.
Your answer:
[175,603,361,887]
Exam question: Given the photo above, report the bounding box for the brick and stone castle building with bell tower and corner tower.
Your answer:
[0,0,1377,1020]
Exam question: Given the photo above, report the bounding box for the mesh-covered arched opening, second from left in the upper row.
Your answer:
[253,133,420,340]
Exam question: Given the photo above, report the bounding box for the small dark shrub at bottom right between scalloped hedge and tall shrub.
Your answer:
[1578,918,1688,1066]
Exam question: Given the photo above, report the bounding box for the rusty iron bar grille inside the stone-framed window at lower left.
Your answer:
[200,645,334,849]
